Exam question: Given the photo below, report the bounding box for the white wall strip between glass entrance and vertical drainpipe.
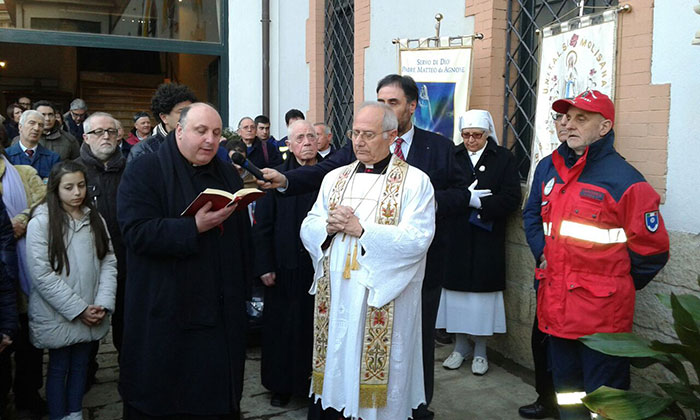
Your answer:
[228,0,262,127]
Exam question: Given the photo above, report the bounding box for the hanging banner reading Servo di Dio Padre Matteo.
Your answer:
[398,36,474,144]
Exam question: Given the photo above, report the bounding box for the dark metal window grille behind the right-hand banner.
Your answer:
[503,0,617,179]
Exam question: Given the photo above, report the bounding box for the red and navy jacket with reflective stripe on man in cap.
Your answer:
[536,131,669,339]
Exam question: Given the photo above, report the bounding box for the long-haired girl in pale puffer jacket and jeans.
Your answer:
[27,161,117,420]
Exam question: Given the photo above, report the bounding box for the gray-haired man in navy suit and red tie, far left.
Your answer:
[5,109,61,183]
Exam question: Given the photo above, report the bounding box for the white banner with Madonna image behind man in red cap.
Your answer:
[528,9,618,185]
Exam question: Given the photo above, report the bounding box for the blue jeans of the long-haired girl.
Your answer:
[46,342,93,420]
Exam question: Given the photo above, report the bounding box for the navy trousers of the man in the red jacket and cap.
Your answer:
[549,336,630,420]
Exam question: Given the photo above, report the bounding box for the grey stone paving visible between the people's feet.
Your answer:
[9,337,536,420]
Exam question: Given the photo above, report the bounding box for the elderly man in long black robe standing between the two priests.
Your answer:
[253,120,323,407]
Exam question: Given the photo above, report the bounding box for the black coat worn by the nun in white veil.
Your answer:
[443,138,521,292]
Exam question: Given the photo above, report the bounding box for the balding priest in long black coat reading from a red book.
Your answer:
[117,103,251,419]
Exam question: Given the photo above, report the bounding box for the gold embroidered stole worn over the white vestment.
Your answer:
[312,156,408,408]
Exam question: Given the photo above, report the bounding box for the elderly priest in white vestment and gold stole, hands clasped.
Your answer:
[301,102,435,420]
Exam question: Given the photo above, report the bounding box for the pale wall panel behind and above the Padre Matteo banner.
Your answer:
[365,0,478,100]
